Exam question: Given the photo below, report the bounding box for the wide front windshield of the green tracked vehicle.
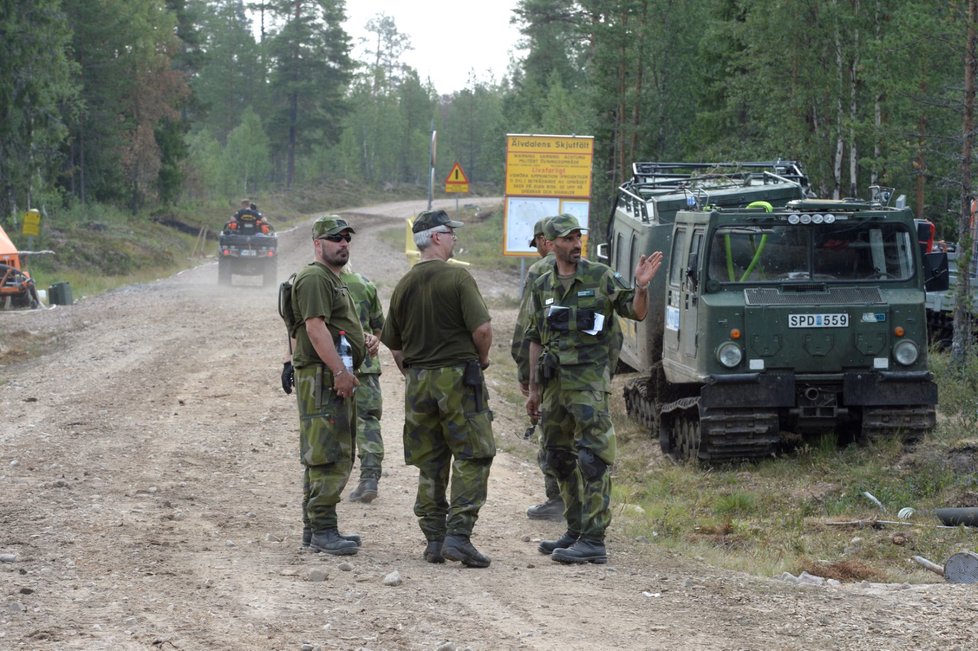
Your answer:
[707,221,914,283]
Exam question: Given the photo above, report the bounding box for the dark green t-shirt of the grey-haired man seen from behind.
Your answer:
[380,260,490,368]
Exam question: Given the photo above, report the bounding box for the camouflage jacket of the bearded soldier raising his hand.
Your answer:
[526,258,636,392]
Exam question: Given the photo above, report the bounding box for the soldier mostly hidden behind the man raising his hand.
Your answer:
[510,217,564,520]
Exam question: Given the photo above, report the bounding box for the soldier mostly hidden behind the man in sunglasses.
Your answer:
[340,264,384,503]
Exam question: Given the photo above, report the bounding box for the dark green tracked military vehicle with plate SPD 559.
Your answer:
[599,161,947,462]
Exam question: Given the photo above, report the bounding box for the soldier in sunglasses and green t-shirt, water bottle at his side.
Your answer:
[290,215,366,555]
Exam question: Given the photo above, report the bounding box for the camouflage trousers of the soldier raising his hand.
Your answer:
[541,378,617,541]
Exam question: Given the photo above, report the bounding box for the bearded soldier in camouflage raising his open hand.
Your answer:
[526,215,662,563]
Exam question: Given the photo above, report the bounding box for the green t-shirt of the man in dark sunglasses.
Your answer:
[292,262,367,368]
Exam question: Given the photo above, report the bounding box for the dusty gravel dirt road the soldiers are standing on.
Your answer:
[0,202,978,651]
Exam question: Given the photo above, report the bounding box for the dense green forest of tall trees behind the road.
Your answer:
[0,0,975,271]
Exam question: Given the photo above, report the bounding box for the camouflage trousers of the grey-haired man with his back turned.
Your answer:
[404,366,496,540]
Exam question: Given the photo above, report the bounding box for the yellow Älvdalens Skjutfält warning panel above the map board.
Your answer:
[506,134,594,198]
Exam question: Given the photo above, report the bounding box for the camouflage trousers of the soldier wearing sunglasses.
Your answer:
[295,366,357,531]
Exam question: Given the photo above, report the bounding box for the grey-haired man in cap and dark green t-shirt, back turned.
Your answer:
[381,210,496,567]
